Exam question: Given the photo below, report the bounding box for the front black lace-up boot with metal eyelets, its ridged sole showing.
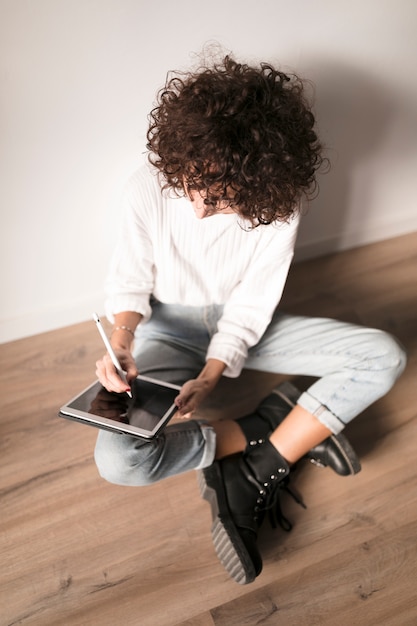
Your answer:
[198,440,290,585]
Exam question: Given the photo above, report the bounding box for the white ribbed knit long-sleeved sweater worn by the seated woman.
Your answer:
[106,165,298,377]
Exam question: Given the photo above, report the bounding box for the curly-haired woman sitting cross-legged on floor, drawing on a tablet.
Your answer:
[96,57,405,583]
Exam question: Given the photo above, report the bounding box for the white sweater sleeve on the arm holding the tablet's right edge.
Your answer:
[206,217,299,378]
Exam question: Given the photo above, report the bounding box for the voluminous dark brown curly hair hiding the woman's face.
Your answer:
[147,56,324,226]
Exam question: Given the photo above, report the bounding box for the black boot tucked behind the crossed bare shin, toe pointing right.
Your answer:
[237,382,361,476]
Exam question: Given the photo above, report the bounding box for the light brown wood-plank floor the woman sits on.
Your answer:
[0,233,417,626]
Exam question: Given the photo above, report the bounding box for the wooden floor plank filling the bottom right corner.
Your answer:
[212,523,417,626]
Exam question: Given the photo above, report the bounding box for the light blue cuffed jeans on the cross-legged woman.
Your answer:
[95,302,406,486]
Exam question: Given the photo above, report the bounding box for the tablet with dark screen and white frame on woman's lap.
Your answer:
[59,375,181,439]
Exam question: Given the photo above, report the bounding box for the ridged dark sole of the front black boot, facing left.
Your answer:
[197,463,259,585]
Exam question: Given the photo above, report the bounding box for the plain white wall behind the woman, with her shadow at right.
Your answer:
[0,0,417,341]
